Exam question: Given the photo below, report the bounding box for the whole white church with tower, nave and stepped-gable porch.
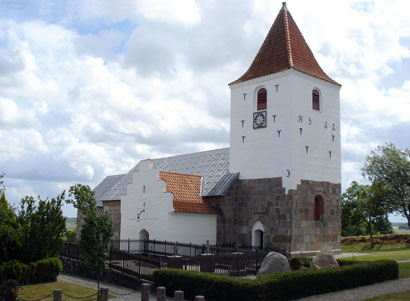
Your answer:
[78,3,341,255]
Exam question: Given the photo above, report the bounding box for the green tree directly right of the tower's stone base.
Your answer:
[342,181,391,248]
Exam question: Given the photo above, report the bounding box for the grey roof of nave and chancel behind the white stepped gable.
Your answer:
[94,148,239,206]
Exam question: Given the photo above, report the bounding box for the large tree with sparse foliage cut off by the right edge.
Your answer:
[363,143,410,227]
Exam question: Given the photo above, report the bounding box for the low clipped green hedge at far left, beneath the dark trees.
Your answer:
[0,257,63,284]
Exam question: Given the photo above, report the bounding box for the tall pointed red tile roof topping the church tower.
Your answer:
[230,2,340,86]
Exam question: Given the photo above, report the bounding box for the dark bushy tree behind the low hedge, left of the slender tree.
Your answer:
[17,192,66,262]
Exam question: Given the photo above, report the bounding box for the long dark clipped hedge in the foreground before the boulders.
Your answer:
[153,260,399,300]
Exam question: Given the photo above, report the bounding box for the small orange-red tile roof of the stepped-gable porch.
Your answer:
[159,171,215,214]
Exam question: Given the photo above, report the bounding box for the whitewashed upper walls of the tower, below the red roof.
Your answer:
[230,70,341,189]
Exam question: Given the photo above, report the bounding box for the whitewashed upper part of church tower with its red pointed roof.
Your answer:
[229,2,341,190]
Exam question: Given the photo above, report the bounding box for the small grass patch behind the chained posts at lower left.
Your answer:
[18,281,114,301]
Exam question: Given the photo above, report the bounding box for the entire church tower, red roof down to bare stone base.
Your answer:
[215,2,341,255]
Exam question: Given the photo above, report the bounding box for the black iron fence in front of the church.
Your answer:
[61,240,284,280]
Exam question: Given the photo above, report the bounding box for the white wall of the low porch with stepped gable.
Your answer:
[121,160,216,244]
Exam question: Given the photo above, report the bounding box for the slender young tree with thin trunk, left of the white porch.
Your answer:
[69,184,114,292]
